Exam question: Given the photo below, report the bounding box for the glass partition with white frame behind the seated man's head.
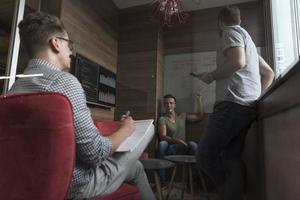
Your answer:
[0,0,40,94]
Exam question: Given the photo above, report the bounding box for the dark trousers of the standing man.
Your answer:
[197,101,256,200]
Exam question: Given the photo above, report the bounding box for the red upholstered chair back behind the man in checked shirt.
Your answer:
[0,93,75,200]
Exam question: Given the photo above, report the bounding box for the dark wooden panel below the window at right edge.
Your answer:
[258,62,300,200]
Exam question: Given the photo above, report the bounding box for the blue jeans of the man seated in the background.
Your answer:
[157,141,198,182]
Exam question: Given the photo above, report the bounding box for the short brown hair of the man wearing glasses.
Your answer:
[18,12,65,57]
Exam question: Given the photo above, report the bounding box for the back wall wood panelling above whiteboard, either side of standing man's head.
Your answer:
[164,1,265,55]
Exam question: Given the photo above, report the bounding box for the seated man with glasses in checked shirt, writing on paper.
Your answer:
[10,13,155,199]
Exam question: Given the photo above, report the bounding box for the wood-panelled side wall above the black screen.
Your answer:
[61,0,118,72]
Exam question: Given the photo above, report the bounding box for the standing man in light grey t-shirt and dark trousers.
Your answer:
[195,6,274,200]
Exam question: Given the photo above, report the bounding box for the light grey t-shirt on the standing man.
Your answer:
[216,25,261,106]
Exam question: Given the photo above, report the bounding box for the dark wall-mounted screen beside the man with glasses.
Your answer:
[74,53,116,107]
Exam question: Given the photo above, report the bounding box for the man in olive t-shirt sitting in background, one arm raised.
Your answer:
[158,94,203,185]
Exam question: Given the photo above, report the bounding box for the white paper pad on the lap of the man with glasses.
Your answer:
[116,119,154,152]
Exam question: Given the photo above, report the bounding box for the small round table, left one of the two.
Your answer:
[140,158,176,200]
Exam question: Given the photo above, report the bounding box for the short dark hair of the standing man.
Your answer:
[218,6,241,26]
